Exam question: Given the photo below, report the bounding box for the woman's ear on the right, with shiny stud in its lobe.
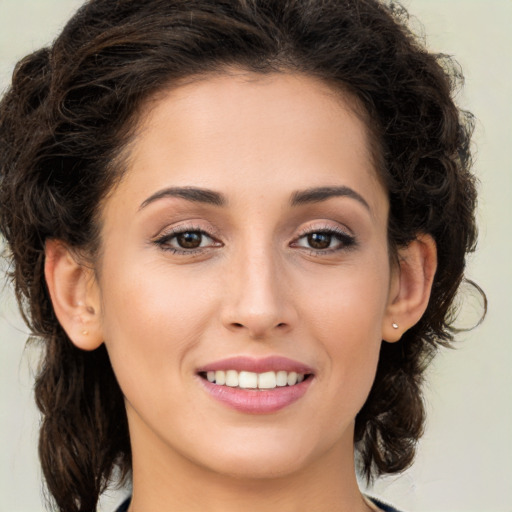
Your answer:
[382,235,437,342]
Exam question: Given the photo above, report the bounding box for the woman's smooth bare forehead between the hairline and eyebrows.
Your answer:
[109,71,383,218]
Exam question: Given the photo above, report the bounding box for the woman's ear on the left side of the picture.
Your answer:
[44,240,103,350]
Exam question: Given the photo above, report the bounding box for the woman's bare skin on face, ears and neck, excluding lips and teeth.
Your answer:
[46,72,435,512]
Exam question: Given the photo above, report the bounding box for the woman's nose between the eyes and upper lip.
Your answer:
[222,245,298,339]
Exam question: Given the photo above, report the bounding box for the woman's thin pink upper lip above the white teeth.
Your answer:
[197,356,313,374]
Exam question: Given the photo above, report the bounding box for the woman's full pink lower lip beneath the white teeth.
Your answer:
[199,376,313,414]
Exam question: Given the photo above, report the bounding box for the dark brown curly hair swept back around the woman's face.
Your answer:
[0,0,476,512]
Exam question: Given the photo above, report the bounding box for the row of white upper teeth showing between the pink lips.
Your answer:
[206,370,304,389]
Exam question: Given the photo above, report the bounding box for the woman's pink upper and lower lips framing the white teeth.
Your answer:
[198,356,314,414]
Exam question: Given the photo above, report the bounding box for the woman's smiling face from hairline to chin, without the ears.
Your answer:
[97,72,394,477]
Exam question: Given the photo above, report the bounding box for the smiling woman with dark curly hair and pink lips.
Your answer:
[0,0,476,512]
